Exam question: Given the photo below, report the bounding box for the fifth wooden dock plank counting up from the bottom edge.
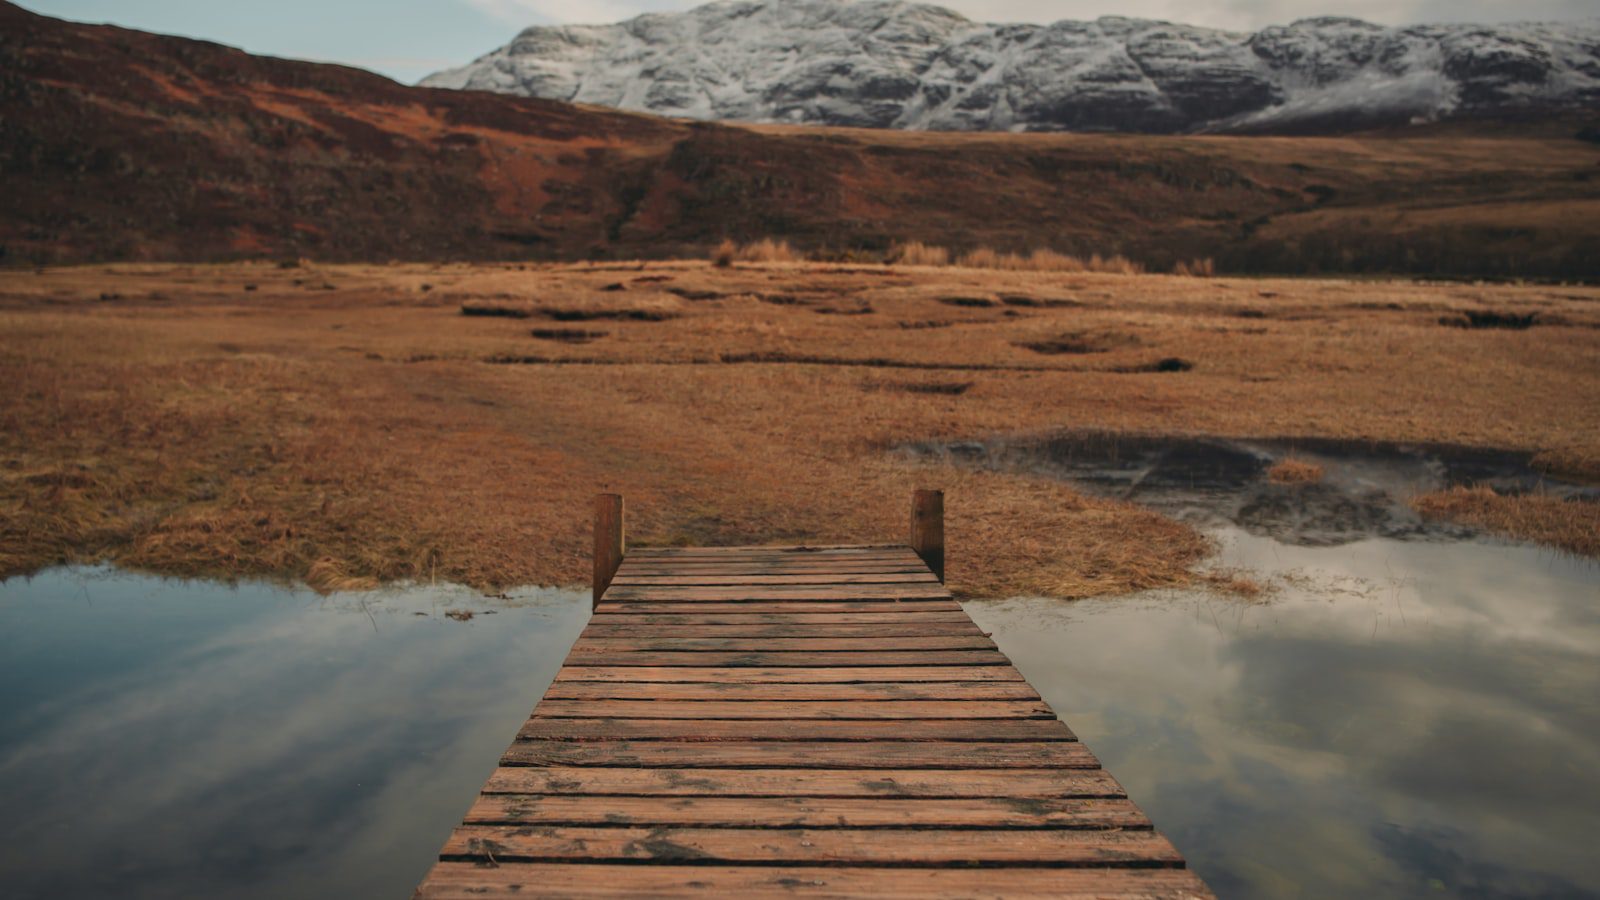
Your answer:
[501,740,1099,769]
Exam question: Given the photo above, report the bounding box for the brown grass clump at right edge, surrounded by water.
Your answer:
[1411,487,1600,556]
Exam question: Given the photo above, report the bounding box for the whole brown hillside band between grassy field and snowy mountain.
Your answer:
[0,3,1600,277]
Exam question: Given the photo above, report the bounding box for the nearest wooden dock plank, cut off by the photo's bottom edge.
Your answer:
[416,862,1211,900]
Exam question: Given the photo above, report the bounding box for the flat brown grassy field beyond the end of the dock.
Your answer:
[0,261,1600,597]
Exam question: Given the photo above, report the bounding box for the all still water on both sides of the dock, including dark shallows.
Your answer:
[0,440,1600,898]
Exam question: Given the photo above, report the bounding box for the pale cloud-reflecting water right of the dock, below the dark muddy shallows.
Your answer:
[968,528,1600,897]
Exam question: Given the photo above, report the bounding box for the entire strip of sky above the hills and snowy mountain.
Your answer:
[21,0,1600,82]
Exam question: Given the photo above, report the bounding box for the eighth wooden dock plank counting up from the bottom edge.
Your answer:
[544,681,1038,703]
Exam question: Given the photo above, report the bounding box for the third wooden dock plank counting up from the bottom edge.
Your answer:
[466,794,1150,830]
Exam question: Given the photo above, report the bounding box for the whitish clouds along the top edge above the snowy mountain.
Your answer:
[466,0,1597,29]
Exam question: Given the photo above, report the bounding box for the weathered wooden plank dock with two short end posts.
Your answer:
[416,492,1211,900]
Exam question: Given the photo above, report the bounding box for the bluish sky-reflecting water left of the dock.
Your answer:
[0,570,587,897]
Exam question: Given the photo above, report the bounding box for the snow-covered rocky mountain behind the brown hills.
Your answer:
[422,0,1600,131]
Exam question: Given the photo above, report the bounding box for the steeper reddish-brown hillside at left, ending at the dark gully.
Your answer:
[0,3,683,259]
